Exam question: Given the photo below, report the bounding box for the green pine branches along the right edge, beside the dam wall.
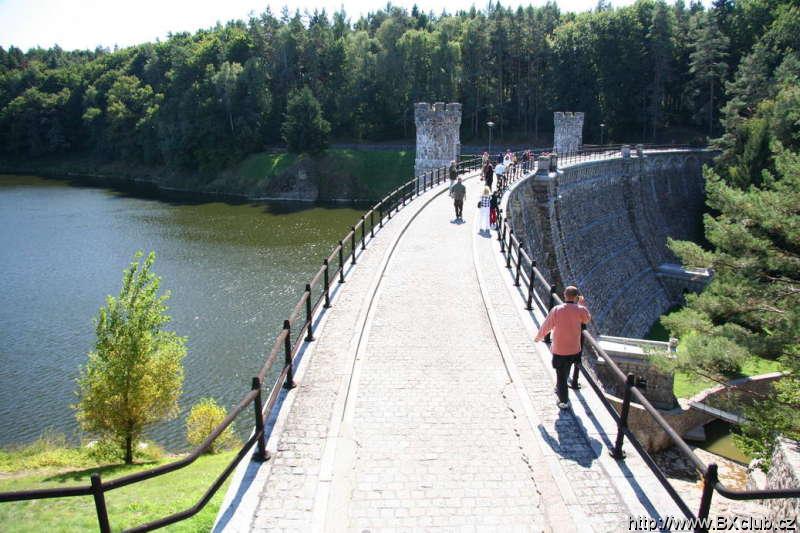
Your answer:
[664,67,800,459]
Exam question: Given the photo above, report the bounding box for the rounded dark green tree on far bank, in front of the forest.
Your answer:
[281,87,331,153]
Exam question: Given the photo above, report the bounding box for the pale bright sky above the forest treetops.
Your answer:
[0,0,664,50]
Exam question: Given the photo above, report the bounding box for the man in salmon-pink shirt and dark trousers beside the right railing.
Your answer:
[535,285,592,409]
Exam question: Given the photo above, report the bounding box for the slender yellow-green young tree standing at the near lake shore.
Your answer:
[75,252,186,463]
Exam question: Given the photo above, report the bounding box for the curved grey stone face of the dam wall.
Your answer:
[507,149,714,337]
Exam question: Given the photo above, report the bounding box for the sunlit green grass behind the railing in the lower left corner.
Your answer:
[0,439,235,532]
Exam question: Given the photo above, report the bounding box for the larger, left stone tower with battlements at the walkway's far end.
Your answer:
[414,102,461,176]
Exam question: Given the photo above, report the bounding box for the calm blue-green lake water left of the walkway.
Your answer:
[0,176,363,450]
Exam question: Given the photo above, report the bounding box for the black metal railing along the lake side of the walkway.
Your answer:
[0,153,481,533]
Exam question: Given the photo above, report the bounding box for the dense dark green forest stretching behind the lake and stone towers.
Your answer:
[0,0,781,169]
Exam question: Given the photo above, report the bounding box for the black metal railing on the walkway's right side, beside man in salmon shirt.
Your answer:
[497,146,800,533]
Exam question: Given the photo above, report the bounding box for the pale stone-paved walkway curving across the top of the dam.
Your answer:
[218,172,678,532]
